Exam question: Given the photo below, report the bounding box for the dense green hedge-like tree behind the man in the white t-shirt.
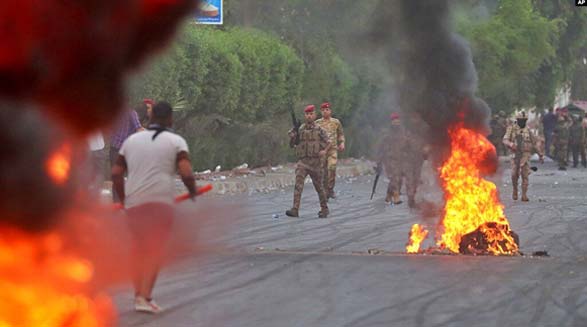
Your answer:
[131,25,304,168]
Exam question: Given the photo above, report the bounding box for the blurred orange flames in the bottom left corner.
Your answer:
[0,229,114,327]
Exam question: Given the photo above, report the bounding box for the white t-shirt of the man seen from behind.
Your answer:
[119,130,188,208]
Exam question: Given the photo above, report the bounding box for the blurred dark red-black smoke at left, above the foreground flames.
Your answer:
[0,0,198,231]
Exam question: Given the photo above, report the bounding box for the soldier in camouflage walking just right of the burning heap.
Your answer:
[503,111,544,202]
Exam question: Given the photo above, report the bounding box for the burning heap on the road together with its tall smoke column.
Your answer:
[372,0,519,255]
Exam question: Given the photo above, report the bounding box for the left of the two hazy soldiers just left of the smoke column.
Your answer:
[378,113,406,204]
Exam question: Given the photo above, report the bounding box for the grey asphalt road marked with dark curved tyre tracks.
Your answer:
[115,160,587,327]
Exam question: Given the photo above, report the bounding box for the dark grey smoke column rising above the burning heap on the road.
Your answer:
[370,0,489,156]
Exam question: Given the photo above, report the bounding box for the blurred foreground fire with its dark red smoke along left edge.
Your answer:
[0,0,197,326]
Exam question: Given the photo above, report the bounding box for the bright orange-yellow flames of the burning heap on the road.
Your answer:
[437,124,518,255]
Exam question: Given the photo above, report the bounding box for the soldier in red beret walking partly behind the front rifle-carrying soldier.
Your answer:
[316,102,344,198]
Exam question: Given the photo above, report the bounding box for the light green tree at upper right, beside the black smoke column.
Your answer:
[460,0,560,112]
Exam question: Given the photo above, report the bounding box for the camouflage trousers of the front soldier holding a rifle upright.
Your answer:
[293,158,328,210]
